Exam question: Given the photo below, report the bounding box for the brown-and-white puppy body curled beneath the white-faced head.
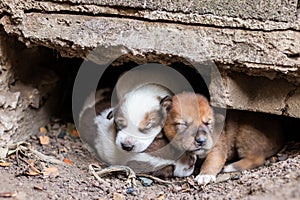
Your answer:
[79,87,196,177]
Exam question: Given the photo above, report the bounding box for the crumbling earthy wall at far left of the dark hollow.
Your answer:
[0,31,58,146]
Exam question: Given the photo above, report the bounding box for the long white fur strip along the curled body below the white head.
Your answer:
[94,108,192,177]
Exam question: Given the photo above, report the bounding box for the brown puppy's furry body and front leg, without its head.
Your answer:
[200,110,284,175]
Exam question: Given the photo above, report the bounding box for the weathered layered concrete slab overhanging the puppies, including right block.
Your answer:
[0,0,300,144]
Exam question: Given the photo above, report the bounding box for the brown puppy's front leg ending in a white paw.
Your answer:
[195,146,227,185]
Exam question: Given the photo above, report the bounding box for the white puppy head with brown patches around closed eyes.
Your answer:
[108,84,172,152]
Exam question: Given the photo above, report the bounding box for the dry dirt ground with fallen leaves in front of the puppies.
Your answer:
[0,121,300,200]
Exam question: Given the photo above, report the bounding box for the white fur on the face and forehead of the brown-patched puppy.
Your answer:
[116,84,171,152]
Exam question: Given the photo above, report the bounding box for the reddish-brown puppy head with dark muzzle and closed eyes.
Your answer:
[164,92,215,157]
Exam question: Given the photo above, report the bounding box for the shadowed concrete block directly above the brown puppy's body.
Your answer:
[210,73,300,117]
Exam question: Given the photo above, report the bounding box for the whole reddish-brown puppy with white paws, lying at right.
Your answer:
[165,93,284,184]
